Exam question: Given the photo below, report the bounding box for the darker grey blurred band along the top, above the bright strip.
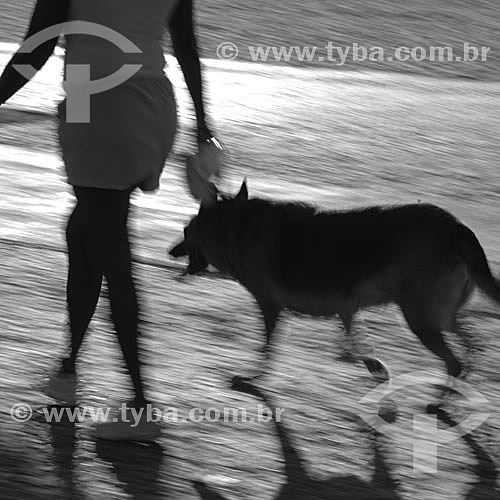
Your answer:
[0,0,500,81]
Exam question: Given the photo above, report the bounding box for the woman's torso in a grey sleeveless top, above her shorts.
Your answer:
[65,0,182,80]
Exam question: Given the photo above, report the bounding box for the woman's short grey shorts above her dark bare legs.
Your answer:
[59,77,177,191]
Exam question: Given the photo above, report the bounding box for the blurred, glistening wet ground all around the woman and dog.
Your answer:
[0,0,500,500]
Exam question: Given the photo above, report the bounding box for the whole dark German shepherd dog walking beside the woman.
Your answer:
[170,181,500,394]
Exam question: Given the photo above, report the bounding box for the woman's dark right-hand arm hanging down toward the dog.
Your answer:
[170,0,212,142]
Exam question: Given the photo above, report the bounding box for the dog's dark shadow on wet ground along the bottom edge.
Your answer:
[193,382,401,500]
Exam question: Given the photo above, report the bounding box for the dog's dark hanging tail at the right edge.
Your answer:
[456,224,500,305]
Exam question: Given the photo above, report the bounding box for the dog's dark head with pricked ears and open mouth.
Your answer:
[169,180,248,274]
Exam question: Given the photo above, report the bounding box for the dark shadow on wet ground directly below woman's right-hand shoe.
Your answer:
[96,440,165,500]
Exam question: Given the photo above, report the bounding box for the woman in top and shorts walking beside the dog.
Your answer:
[0,0,217,440]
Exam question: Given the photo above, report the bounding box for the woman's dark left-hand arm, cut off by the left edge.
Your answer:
[0,0,69,105]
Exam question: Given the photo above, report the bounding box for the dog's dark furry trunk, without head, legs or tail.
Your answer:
[226,199,461,315]
